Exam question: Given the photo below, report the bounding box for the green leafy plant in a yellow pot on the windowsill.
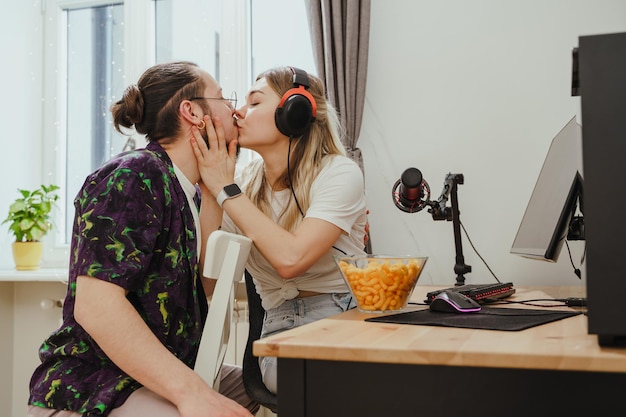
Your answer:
[2,184,59,270]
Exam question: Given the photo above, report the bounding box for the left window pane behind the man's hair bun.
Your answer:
[63,4,126,242]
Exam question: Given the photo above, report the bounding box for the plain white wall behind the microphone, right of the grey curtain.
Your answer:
[359,0,626,286]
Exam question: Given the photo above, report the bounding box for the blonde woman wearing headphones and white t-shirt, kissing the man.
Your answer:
[191,67,366,392]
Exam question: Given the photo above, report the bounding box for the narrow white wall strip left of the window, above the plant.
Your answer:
[0,0,43,269]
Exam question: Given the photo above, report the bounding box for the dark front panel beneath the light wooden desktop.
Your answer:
[278,358,626,417]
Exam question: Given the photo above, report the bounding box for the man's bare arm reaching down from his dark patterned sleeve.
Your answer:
[74,276,251,417]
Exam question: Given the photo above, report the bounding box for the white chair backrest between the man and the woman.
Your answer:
[195,230,252,390]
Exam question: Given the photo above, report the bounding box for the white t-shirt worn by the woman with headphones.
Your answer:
[222,156,367,310]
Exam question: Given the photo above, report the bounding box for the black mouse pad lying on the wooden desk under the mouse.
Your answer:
[365,307,581,331]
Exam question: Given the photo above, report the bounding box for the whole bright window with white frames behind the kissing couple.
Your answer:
[43,0,315,266]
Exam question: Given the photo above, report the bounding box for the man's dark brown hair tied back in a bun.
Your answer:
[111,61,206,142]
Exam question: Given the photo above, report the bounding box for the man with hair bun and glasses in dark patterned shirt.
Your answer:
[28,62,257,417]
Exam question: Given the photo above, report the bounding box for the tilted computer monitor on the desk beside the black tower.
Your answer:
[510,117,583,262]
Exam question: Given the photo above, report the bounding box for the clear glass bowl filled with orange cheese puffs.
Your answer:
[334,255,428,313]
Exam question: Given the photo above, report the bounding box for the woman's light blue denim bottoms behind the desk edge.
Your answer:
[259,293,355,393]
